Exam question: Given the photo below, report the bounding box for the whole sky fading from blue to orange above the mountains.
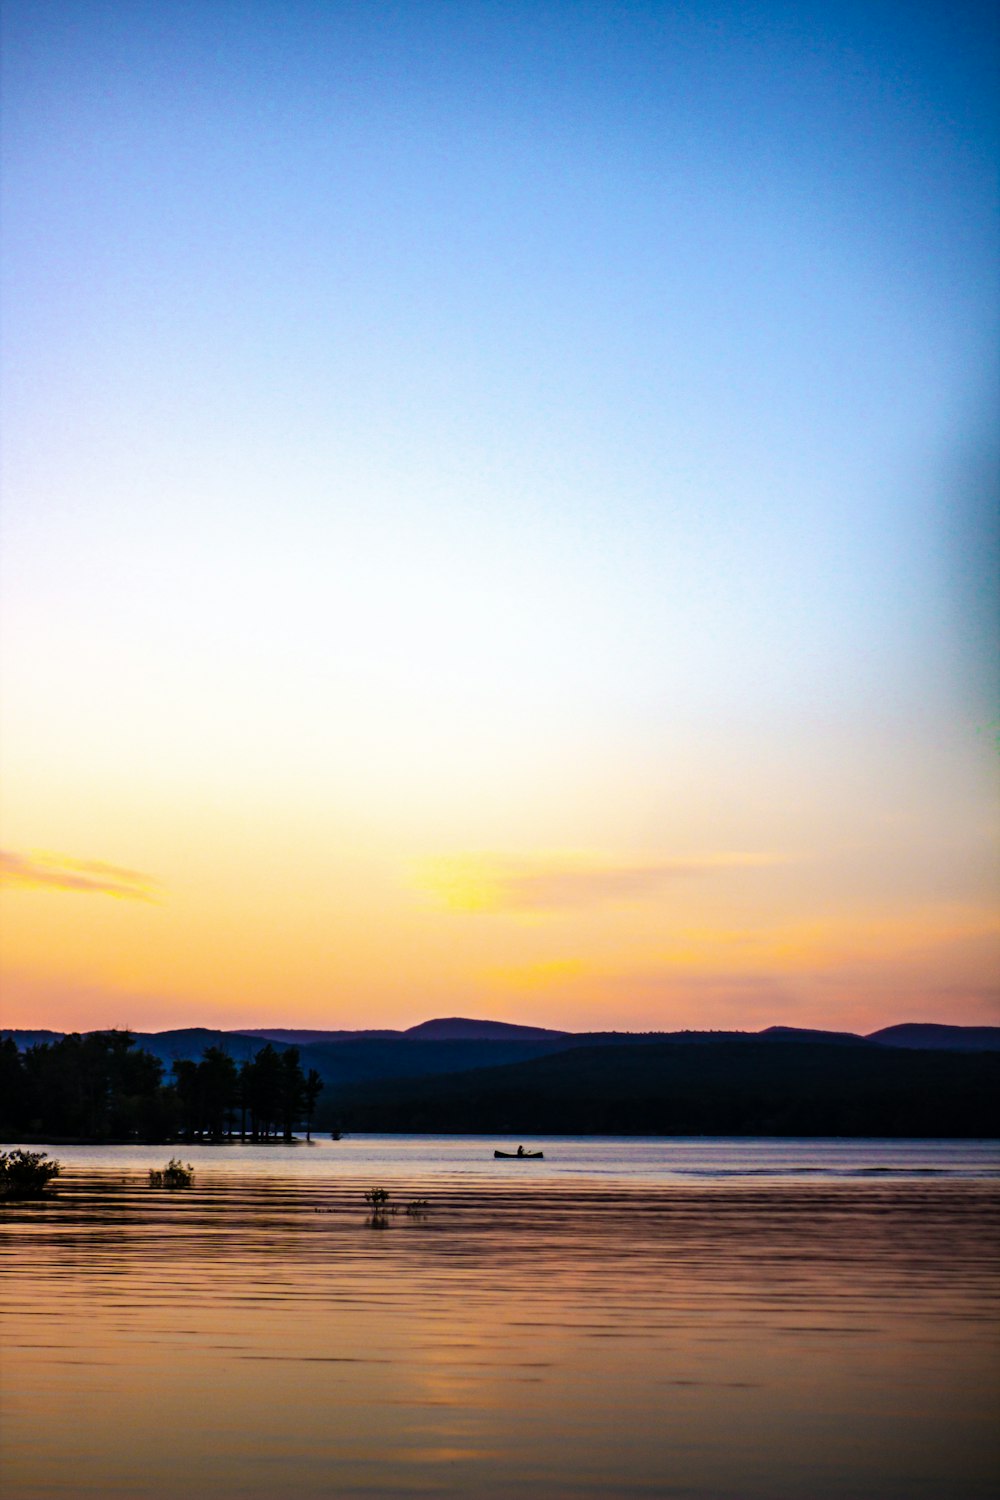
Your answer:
[0,0,1000,1031]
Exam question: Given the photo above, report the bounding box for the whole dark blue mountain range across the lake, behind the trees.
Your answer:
[1,1017,1000,1136]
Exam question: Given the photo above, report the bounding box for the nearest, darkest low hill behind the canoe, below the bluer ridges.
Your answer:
[330,1038,1000,1137]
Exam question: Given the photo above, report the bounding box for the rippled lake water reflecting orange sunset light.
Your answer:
[0,1136,1000,1500]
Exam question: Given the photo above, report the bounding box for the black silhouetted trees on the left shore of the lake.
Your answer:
[0,1031,322,1143]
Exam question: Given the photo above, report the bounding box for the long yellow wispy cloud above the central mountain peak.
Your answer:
[418,852,784,914]
